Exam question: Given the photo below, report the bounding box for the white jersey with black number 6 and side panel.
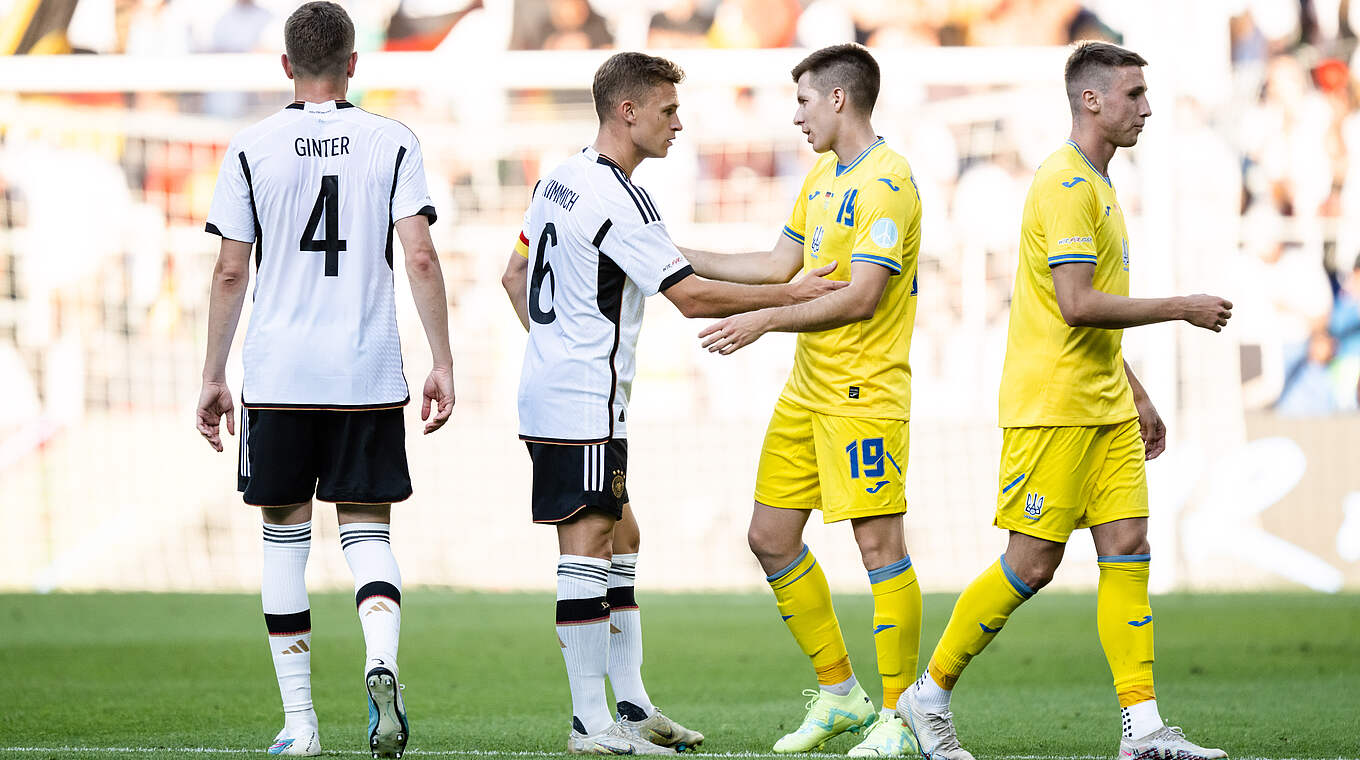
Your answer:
[520,148,694,443]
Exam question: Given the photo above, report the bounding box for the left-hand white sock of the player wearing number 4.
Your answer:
[260,521,317,736]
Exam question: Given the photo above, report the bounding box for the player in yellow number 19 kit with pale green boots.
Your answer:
[684,45,921,757]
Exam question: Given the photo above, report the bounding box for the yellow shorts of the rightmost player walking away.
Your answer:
[993,419,1148,542]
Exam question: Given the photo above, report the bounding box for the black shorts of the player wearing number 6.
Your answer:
[525,438,628,522]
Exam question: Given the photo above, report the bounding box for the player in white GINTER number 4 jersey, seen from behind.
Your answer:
[197,3,454,757]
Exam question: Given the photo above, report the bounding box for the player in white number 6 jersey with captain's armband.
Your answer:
[503,53,846,755]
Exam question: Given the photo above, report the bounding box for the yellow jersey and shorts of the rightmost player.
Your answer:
[996,140,1148,541]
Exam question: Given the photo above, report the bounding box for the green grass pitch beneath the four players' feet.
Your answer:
[0,589,1360,760]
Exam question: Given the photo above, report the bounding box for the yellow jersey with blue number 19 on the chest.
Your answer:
[783,137,921,420]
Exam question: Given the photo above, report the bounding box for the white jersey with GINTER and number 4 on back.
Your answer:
[207,101,435,409]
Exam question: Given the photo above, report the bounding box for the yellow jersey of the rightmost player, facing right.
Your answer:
[1000,140,1138,427]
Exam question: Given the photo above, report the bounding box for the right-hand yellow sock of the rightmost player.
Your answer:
[1096,555,1156,707]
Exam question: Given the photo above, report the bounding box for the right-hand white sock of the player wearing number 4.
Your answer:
[340,522,401,676]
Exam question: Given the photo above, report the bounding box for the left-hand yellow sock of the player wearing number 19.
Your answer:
[766,545,854,687]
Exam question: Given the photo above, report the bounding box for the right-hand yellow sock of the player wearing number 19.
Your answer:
[869,556,921,710]
